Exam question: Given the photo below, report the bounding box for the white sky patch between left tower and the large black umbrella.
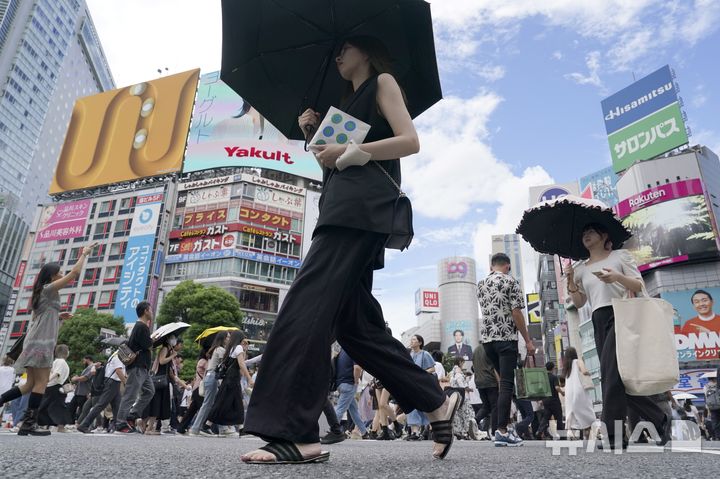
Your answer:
[87,0,222,87]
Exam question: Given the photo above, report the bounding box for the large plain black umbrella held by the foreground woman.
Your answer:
[221,0,442,140]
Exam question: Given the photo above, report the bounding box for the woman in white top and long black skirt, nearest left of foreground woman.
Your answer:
[208,331,253,432]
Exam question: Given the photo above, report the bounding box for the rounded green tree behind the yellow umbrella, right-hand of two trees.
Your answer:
[157,280,243,379]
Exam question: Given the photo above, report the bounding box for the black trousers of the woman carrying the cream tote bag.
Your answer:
[592,306,669,442]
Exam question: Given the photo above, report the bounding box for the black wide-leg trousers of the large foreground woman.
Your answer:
[245,227,445,444]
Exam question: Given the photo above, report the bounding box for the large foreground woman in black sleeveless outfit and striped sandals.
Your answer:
[242,37,462,464]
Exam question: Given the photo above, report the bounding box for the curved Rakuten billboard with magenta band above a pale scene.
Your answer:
[616,179,718,271]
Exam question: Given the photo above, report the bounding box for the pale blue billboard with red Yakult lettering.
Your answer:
[183,72,322,181]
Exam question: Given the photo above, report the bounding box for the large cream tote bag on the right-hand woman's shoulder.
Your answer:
[612,297,680,396]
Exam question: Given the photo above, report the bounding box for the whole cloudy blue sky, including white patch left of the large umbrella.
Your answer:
[88,0,720,336]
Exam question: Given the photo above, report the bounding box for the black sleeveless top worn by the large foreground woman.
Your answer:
[313,76,400,242]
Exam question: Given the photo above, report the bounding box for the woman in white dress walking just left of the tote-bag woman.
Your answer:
[563,348,595,437]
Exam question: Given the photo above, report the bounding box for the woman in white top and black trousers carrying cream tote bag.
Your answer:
[567,223,670,448]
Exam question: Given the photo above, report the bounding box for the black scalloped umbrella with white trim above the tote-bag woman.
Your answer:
[516,195,632,260]
